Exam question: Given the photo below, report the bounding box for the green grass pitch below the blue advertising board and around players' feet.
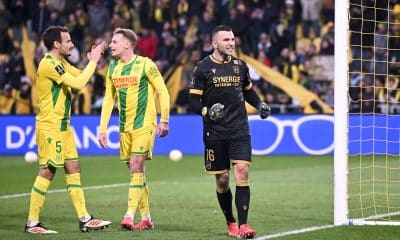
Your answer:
[0,156,398,240]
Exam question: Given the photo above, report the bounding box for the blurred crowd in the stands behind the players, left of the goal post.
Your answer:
[0,0,340,114]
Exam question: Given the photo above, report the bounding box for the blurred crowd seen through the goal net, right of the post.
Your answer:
[349,0,400,114]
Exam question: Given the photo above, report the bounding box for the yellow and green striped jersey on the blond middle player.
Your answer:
[100,55,169,133]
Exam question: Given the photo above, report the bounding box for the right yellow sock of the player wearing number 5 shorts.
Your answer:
[65,173,89,218]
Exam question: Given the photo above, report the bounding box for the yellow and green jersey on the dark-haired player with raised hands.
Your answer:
[36,54,96,131]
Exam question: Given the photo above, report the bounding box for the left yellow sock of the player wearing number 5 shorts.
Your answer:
[28,176,51,221]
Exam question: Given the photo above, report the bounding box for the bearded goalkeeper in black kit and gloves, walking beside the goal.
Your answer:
[189,25,271,238]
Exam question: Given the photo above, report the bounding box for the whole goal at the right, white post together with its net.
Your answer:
[333,0,400,226]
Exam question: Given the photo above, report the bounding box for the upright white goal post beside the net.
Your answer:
[333,0,349,225]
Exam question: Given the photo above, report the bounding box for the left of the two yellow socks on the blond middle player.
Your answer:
[127,173,144,216]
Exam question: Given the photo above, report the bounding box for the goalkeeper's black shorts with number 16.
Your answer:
[204,135,251,174]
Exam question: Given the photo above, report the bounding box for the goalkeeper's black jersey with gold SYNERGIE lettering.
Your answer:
[190,55,251,139]
